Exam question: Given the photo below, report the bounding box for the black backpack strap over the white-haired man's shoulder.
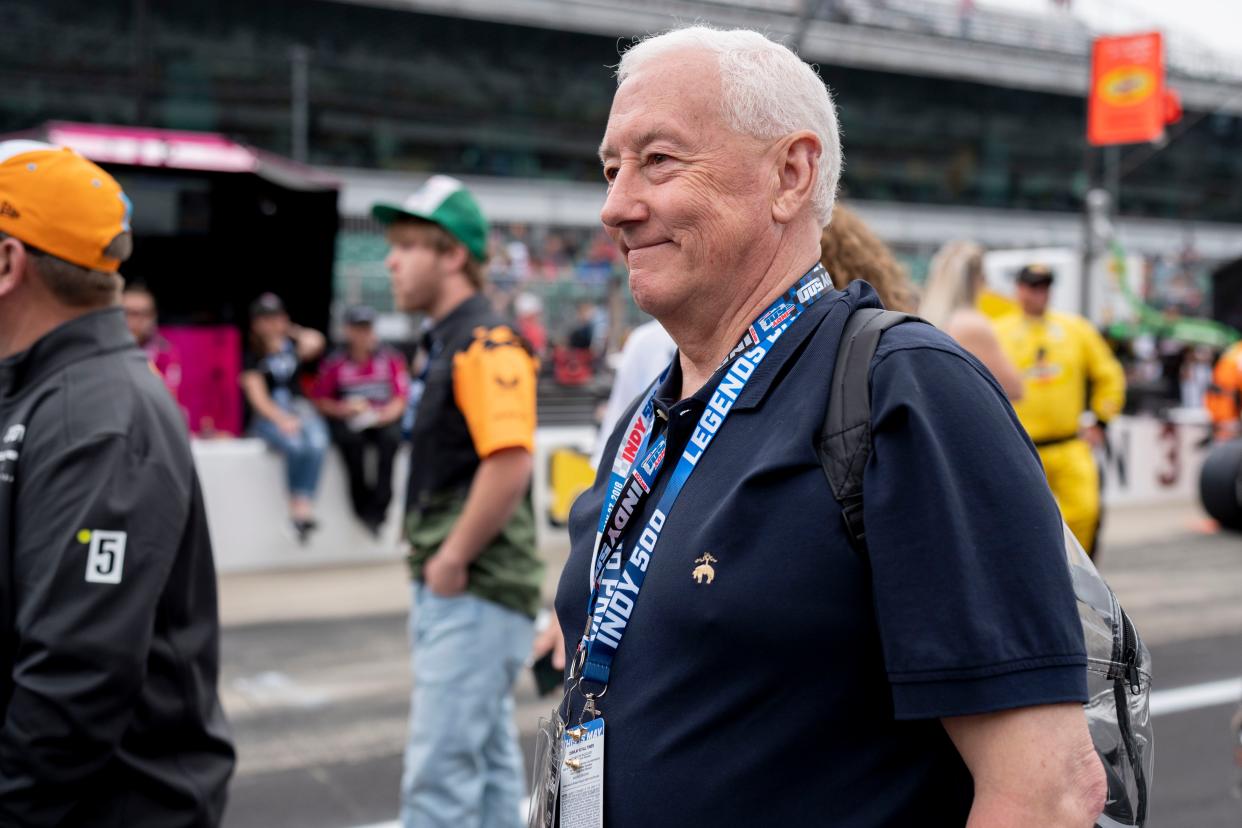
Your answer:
[817,308,925,552]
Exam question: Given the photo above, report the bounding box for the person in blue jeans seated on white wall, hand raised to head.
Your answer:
[241,293,328,544]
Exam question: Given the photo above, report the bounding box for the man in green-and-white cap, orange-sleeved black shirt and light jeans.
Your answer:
[373,175,543,828]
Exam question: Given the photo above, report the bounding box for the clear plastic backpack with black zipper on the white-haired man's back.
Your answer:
[1064,528,1155,828]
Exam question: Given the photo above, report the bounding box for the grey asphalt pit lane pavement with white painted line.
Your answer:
[221,505,1242,828]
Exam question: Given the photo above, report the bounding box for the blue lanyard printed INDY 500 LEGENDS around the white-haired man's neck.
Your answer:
[579,264,830,698]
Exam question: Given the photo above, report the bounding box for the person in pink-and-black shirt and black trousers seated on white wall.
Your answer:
[314,305,410,535]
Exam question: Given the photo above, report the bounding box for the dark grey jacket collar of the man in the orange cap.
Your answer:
[0,305,138,396]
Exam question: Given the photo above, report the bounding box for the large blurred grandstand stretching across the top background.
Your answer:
[0,0,1242,312]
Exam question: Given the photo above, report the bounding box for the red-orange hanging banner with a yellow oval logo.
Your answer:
[1087,32,1166,146]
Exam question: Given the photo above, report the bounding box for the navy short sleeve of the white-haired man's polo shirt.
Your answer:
[863,329,1087,719]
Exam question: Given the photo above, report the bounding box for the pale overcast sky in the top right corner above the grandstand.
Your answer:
[976,0,1242,58]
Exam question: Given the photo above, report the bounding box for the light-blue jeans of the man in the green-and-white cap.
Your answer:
[401,581,534,828]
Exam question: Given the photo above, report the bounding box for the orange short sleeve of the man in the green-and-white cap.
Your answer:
[453,326,535,457]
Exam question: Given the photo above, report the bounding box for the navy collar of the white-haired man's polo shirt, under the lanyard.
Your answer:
[653,282,883,418]
